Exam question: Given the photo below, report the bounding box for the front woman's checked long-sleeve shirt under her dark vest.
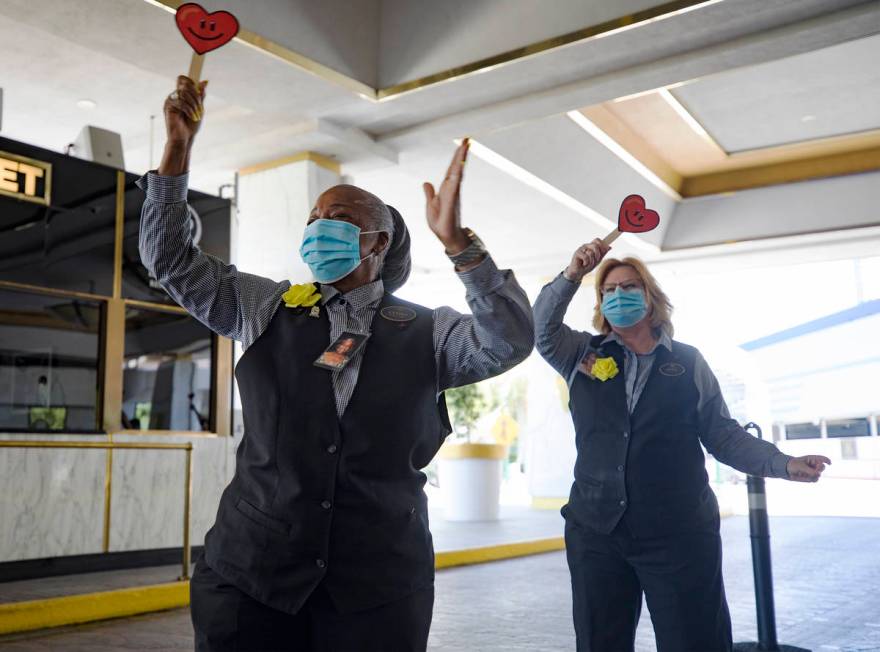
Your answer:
[137,172,534,416]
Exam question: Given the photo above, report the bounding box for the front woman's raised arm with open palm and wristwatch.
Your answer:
[423,139,534,392]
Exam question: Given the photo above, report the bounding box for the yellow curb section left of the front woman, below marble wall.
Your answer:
[0,582,189,634]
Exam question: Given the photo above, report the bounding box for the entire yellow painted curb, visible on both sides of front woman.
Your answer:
[0,537,565,635]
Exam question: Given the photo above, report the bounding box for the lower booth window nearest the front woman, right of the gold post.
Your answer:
[122,306,214,431]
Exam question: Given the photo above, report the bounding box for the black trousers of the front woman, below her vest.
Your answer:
[190,560,434,652]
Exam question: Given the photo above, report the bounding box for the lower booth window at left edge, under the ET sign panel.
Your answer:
[0,289,103,432]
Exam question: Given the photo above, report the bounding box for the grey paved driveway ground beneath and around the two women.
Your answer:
[0,517,880,652]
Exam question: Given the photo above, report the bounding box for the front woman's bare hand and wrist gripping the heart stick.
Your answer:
[158,75,208,176]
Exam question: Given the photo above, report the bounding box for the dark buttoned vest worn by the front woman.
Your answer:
[205,295,450,613]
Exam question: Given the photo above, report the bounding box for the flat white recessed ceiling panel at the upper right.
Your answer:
[672,34,880,152]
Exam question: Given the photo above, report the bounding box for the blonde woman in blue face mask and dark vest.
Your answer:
[534,239,831,652]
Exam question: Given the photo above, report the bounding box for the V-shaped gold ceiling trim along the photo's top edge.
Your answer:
[144,0,723,102]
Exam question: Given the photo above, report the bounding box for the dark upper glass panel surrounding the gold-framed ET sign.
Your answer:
[0,138,116,295]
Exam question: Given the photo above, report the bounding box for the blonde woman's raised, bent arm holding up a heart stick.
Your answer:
[535,238,610,381]
